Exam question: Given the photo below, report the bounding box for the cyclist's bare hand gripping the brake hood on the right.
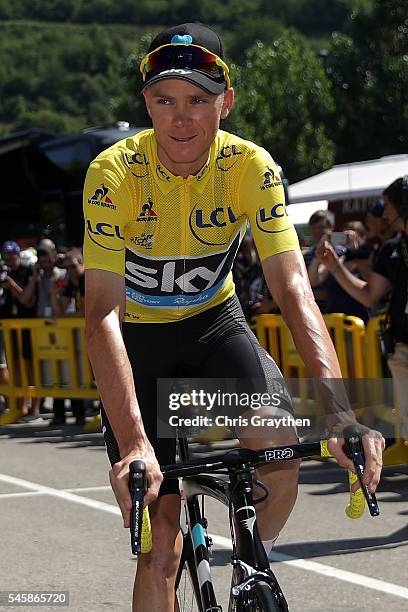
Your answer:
[327,429,385,493]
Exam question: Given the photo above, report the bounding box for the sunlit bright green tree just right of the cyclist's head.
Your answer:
[226,30,334,180]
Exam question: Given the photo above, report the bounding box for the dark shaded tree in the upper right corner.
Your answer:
[327,0,408,162]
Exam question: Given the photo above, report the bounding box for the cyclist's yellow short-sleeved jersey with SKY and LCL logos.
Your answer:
[84,130,299,323]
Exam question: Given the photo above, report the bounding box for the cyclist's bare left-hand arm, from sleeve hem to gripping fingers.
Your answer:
[85,269,163,516]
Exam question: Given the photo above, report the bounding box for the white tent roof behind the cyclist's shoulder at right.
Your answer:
[289,155,408,203]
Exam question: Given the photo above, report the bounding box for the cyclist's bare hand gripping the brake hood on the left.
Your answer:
[109,440,163,528]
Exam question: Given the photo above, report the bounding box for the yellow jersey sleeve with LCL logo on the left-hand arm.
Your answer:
[83,149,133,275]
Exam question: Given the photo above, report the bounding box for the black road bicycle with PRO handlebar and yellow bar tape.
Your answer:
[129,429,379,612]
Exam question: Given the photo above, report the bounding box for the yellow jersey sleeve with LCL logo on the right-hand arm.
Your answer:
[238,147,300,261]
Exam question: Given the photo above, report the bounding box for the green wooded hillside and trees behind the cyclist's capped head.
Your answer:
[0,0,408,181]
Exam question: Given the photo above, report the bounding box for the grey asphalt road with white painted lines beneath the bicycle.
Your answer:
[0,423,408,612]
